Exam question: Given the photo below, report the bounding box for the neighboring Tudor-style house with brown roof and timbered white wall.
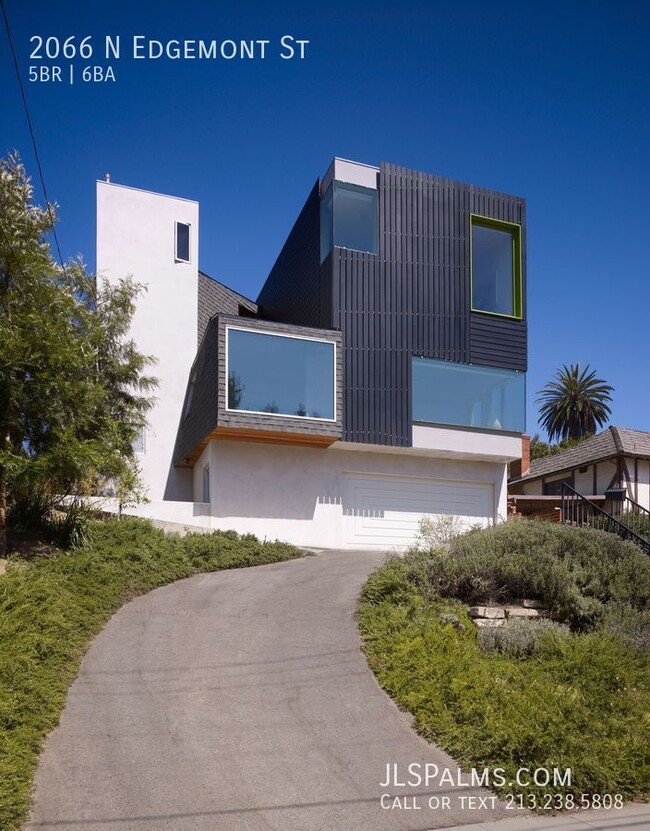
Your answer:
[508,427,650,510]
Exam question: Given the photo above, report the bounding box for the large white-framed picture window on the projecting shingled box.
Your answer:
[227,328,336,421]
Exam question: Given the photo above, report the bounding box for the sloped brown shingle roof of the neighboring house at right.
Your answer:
[512,427,650,482]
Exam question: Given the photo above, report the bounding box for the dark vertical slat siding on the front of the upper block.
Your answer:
[331,164,527,446]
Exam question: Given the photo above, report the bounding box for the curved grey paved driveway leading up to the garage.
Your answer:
[28,552,505,831]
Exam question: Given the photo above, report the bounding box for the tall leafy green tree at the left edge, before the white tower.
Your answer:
[0,154,157,556]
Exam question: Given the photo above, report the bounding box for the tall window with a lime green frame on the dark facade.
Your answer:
[470,214,522,319]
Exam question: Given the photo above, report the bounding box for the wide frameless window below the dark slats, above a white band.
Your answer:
[413,358,526,433]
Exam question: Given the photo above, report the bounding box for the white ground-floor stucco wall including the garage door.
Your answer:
[186,440,506,549]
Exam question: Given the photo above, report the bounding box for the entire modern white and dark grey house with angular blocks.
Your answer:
[97,159,527,549]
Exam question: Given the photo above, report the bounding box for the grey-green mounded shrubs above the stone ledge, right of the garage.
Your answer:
[407,520,650,630]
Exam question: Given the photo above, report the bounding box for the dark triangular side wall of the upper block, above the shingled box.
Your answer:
[257,182,322,326]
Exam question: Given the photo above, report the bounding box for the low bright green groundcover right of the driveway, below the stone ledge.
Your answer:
[358,564,650,799]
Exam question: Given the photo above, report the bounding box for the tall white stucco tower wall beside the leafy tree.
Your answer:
[97,182,199,501]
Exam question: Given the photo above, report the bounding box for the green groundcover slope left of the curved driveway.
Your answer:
[0,519,301,831]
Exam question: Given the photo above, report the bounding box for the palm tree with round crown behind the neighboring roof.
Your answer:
[535,363,614,441]
